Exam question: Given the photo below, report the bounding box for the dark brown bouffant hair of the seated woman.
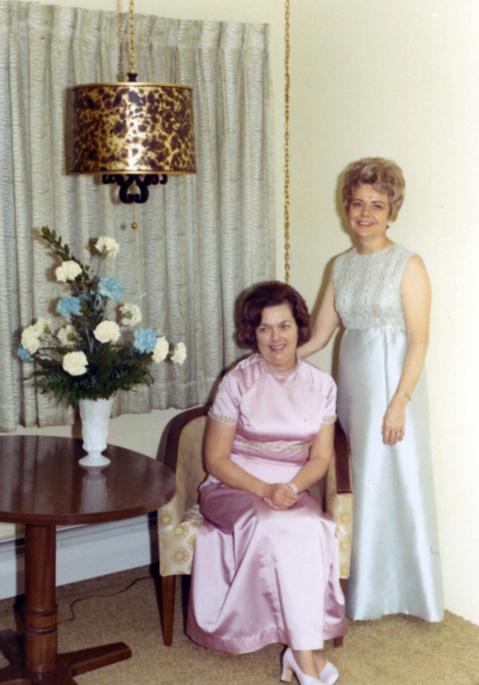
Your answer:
[236,281,311,350]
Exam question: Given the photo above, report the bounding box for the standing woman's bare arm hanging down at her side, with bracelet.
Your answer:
[382,255,431,445]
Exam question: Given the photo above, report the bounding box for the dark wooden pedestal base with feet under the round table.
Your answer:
[0,525,131,685]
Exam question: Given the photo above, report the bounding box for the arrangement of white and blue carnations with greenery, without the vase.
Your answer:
[17,226,186,406]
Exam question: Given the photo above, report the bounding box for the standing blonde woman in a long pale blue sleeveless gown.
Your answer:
[299,158,443,621]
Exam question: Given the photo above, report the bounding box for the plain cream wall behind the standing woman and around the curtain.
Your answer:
[7,0,479,624]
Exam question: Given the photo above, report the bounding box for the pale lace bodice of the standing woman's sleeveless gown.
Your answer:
[333,244,412,329]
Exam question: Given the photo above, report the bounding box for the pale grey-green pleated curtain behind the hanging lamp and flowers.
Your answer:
[0,0,274,431]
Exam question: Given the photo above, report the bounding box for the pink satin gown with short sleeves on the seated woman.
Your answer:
[187,354,345,654]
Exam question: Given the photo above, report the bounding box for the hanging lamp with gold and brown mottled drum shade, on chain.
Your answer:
[69,0,196,204]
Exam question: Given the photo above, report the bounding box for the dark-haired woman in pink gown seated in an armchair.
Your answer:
[187,281,345,685]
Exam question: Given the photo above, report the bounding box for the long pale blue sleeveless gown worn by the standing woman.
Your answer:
[333,244,443,621]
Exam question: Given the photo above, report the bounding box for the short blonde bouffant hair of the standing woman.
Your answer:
[343,157,406,221]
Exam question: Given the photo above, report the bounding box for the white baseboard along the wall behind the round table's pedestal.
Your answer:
[0,515,158,599]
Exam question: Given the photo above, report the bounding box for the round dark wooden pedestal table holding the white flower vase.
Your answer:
[0,435,175,685]
